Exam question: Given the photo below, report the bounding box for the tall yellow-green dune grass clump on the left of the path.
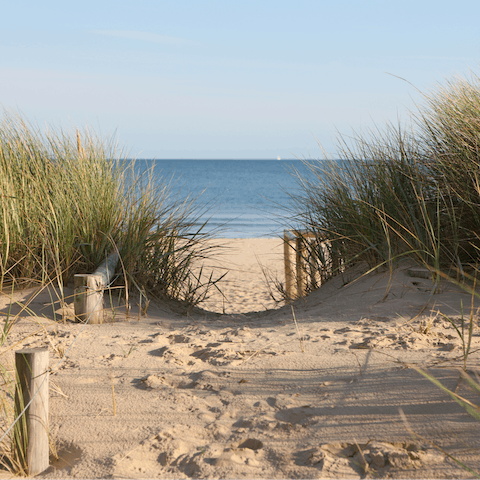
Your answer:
[0,109,222,304]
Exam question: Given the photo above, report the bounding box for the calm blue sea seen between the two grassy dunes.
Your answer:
[133,160,314,238]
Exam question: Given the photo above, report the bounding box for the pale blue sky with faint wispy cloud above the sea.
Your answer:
[0,0,480,159]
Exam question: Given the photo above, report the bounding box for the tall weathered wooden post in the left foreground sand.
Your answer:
[14,348,50,475]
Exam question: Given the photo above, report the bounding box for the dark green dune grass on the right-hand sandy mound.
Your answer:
[291,73,480,477]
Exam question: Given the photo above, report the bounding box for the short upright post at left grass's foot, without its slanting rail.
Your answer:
[73,274,104,323]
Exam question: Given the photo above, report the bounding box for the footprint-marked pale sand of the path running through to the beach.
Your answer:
[0,239,480,480]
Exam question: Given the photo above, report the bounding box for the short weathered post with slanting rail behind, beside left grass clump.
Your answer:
[73,252,118,323]
